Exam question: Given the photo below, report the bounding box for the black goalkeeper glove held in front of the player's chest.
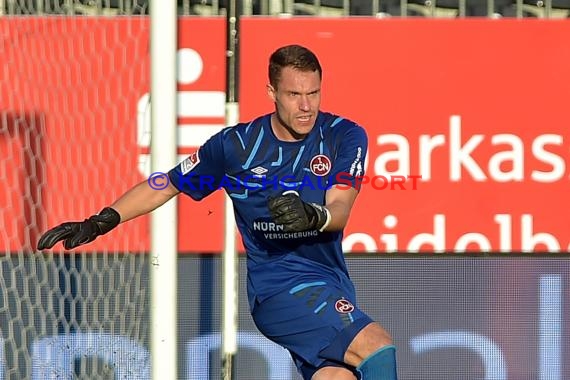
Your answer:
[267,191,331,232]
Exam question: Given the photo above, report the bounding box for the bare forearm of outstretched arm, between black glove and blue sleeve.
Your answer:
[110,180,179,223]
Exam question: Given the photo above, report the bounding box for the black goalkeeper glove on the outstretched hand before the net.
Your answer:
[38,207,121,250]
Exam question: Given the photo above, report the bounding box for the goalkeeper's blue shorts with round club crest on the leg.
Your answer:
[252,279,372,379]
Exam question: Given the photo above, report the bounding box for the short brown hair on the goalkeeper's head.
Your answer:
[269,45,323,88]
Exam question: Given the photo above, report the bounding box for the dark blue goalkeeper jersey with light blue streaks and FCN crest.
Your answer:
[169,112,368,306]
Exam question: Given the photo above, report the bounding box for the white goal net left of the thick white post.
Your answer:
[0,17,150,380]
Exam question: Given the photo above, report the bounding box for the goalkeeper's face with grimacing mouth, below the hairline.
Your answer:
[267,67,321,140]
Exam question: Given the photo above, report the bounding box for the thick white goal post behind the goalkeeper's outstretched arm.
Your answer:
[149,0,178,380]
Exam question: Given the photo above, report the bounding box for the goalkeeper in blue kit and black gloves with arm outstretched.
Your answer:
[38,45,397,380]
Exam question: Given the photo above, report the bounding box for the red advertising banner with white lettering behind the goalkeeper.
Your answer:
[0,18,570,253]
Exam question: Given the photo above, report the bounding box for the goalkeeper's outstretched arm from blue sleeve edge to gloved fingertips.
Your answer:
[38,181,178,250]
